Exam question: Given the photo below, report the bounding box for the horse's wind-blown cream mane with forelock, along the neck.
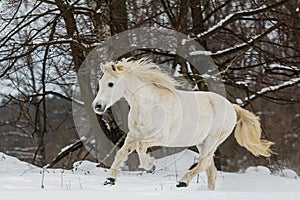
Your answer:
[101,58,181,92]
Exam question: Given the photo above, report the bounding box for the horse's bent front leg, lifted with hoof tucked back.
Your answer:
[136,142,155,173]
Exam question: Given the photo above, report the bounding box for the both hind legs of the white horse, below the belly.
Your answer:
[177,150,215,189]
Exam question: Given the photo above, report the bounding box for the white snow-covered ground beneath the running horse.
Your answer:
[0,151,300,200]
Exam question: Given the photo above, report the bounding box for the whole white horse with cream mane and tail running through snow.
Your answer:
[92,59,273,190]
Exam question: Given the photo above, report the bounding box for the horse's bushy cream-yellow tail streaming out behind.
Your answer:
[233,104,274,157]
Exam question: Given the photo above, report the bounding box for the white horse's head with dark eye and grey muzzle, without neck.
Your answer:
[92,62,126,115]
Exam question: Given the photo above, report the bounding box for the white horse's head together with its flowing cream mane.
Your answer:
[92,58,180,114]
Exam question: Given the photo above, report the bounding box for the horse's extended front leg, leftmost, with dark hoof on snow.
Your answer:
[104,134,137,185]
